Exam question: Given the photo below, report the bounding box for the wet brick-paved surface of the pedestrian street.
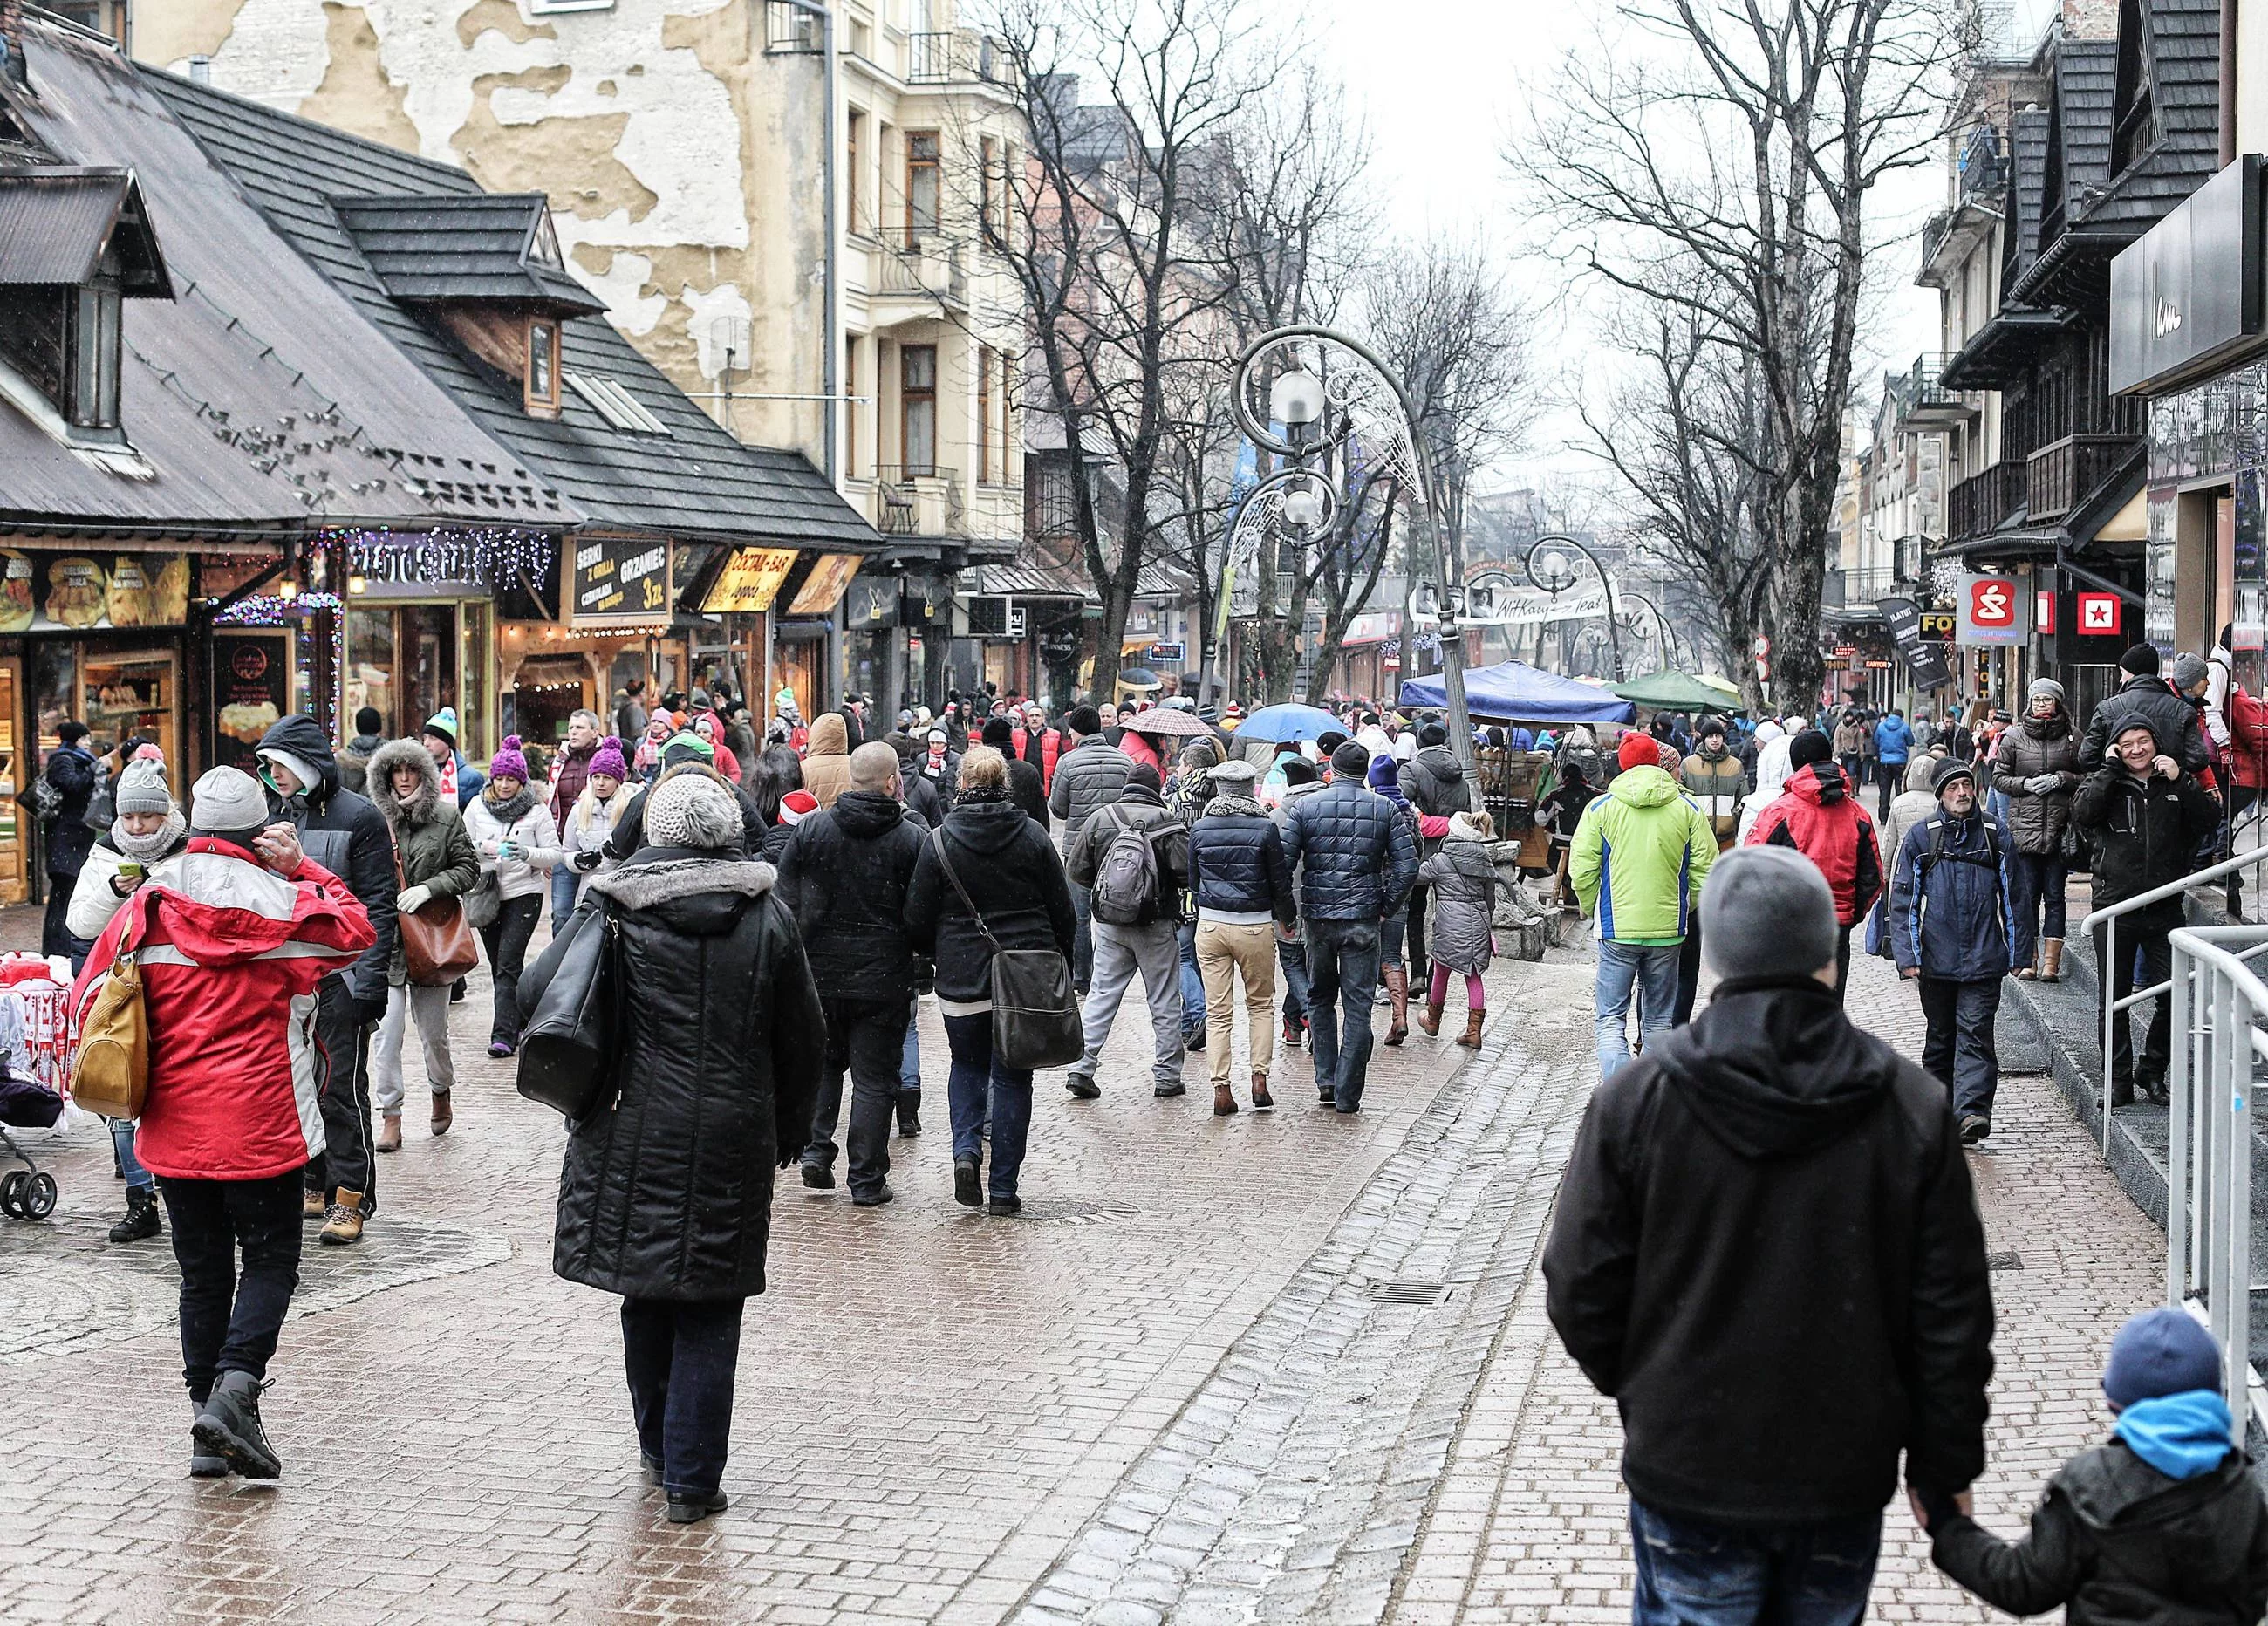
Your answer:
[0,902,2162,1623]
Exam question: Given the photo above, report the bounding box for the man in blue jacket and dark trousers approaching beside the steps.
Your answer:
[1889,757,2014,1145]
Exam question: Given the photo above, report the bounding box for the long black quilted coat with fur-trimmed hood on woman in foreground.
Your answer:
[539,846,825,1301]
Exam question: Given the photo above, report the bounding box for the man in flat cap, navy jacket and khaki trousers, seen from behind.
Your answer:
[1188,757,1297,1118]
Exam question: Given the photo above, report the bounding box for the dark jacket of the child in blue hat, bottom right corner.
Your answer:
[1930,1440,2268,1626]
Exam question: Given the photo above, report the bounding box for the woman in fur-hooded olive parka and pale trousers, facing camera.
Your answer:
[370,740,481,1152]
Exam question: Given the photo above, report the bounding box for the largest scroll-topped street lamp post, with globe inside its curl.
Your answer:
[1229,325,1477,774]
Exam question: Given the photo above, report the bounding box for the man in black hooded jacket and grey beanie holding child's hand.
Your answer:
[1545,846,1993,1623]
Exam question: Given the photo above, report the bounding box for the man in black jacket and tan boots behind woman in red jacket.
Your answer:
[256,714,401,1243]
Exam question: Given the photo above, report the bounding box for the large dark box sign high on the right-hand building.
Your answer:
[2112,154,2264,394]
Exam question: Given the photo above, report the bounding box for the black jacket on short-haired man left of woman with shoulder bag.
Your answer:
[778,791,927,1005]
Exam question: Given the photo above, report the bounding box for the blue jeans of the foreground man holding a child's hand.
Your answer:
[1630,1497,1882,1626]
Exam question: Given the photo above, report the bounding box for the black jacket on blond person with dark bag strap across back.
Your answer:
[905,787,1077,1005]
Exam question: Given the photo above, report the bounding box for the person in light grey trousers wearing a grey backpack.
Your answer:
[1055,766,1188,1100]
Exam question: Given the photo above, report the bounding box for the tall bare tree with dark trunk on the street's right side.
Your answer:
[1508,0,1962,700]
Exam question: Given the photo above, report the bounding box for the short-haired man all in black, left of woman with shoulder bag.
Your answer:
[778,740,927,1209]
